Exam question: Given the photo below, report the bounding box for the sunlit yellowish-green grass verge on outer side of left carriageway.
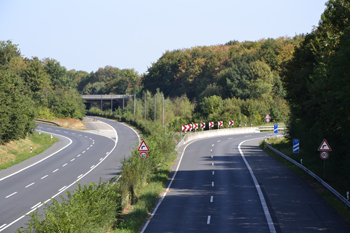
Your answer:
[0,132,58,170]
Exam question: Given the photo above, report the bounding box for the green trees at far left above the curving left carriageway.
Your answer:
[0,41,85,144]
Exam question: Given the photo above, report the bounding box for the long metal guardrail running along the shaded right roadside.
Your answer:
[264,139,350,208]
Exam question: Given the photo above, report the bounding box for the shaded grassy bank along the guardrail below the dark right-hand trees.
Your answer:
[260,137,350,223]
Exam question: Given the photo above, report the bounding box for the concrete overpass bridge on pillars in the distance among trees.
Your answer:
[81,95,135,110]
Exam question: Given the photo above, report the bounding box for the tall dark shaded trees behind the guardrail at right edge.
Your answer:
[282,0,350,187]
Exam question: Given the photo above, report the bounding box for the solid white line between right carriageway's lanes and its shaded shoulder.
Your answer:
[238,138,276,233]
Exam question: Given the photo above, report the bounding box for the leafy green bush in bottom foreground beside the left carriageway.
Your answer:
[17,182,120,233]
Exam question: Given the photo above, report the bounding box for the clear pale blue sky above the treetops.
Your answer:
[0,0,327,74]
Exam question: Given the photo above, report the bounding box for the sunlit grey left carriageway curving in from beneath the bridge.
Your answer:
[0,120,138,232]
